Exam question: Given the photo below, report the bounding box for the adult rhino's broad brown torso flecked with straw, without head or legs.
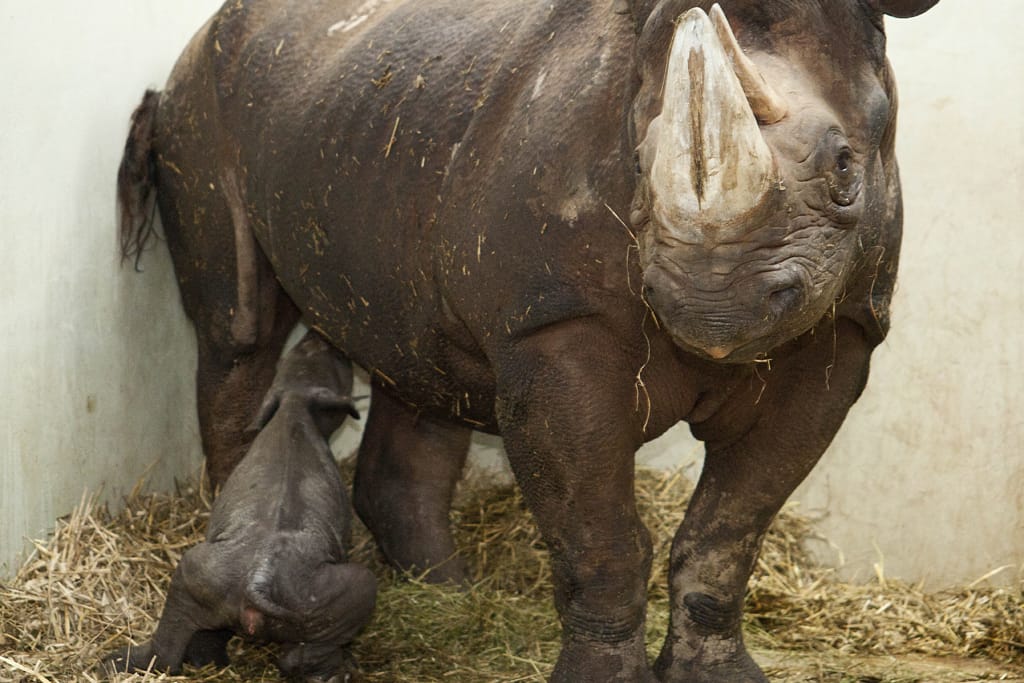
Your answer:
[154,0,632,425]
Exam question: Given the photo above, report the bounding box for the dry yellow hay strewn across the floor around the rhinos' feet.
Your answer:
[0,472,1024,683]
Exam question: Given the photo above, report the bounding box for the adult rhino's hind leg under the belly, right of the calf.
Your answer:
[353,384,472,583]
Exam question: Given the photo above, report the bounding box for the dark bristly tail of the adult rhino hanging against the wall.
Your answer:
[118,90,160,270]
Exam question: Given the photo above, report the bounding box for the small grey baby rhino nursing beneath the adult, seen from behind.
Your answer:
[108,332,377,683]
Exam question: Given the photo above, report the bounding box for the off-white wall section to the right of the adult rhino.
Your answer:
[800,0,1024,587]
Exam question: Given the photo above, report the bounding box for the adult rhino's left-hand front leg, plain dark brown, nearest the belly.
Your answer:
[496,323,653,683]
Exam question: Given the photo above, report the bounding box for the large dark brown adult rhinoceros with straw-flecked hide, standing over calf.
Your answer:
[119,0,936,683]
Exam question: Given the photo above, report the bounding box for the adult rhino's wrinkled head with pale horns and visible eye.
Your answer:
[631,0,936,362]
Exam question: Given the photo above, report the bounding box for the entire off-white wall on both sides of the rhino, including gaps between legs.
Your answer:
[0,0,1024,587]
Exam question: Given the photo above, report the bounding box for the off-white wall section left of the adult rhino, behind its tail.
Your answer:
[0,0,215,575]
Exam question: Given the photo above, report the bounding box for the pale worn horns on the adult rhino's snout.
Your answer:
[641,5,785,239]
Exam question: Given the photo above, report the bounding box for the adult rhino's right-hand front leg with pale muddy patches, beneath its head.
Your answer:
[654,321,871,683]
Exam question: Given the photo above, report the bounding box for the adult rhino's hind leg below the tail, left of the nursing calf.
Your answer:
[160,157,299,486]
